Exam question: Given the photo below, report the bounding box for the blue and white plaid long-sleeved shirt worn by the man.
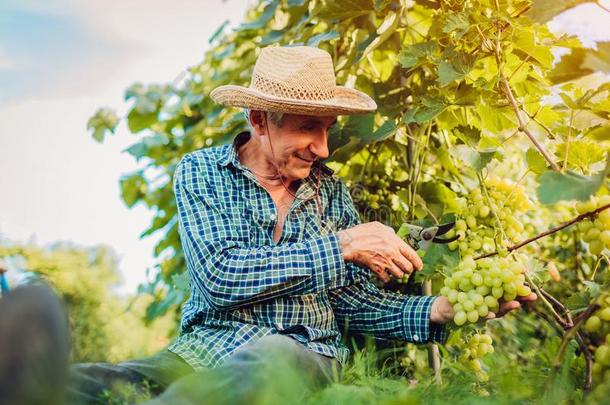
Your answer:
[169,132,446,370]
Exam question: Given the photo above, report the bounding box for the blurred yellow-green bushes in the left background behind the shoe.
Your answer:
[0,243,176,362]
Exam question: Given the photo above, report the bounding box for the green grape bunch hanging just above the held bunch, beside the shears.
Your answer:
[447,177,532,256]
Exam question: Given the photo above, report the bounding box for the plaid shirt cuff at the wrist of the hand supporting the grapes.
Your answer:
[402,296,448,343]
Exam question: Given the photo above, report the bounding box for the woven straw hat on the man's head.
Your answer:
[210,46,377,116]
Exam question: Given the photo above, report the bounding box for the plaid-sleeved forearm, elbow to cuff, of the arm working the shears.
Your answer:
[183,227,345,310]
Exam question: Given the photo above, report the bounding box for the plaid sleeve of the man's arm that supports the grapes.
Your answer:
[329,181,448,343]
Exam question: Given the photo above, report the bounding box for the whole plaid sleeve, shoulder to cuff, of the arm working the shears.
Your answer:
[174,155,346,310]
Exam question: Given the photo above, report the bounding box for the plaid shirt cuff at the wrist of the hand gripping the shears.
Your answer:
[309,233,347,292]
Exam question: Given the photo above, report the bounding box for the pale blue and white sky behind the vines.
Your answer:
[0,0,610,292]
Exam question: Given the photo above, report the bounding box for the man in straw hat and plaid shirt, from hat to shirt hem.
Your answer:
[170,47,452,369]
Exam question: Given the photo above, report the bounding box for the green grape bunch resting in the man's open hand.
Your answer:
[440,256,532,326]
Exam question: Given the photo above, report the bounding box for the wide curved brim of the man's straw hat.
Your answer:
[210,85,377,116]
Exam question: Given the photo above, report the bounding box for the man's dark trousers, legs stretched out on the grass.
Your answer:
[69,335,339,405]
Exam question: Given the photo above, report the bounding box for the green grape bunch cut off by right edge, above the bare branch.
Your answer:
[576,195,610,256]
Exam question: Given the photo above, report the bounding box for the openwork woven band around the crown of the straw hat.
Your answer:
[250,75,335,101]
